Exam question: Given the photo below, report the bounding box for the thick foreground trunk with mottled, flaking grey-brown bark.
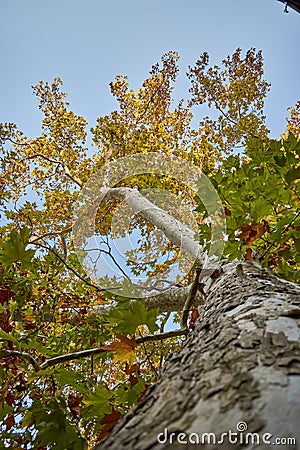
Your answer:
[97,262,300,450]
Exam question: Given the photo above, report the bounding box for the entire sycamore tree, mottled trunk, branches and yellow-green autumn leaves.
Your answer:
[0,49,300,450]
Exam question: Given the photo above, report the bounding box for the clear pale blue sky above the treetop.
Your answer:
[0,0,300,137]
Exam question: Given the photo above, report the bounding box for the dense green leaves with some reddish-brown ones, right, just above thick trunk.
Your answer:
[199,133,300,282]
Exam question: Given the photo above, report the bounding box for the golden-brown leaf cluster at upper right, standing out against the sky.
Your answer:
[188,48,270,153]
